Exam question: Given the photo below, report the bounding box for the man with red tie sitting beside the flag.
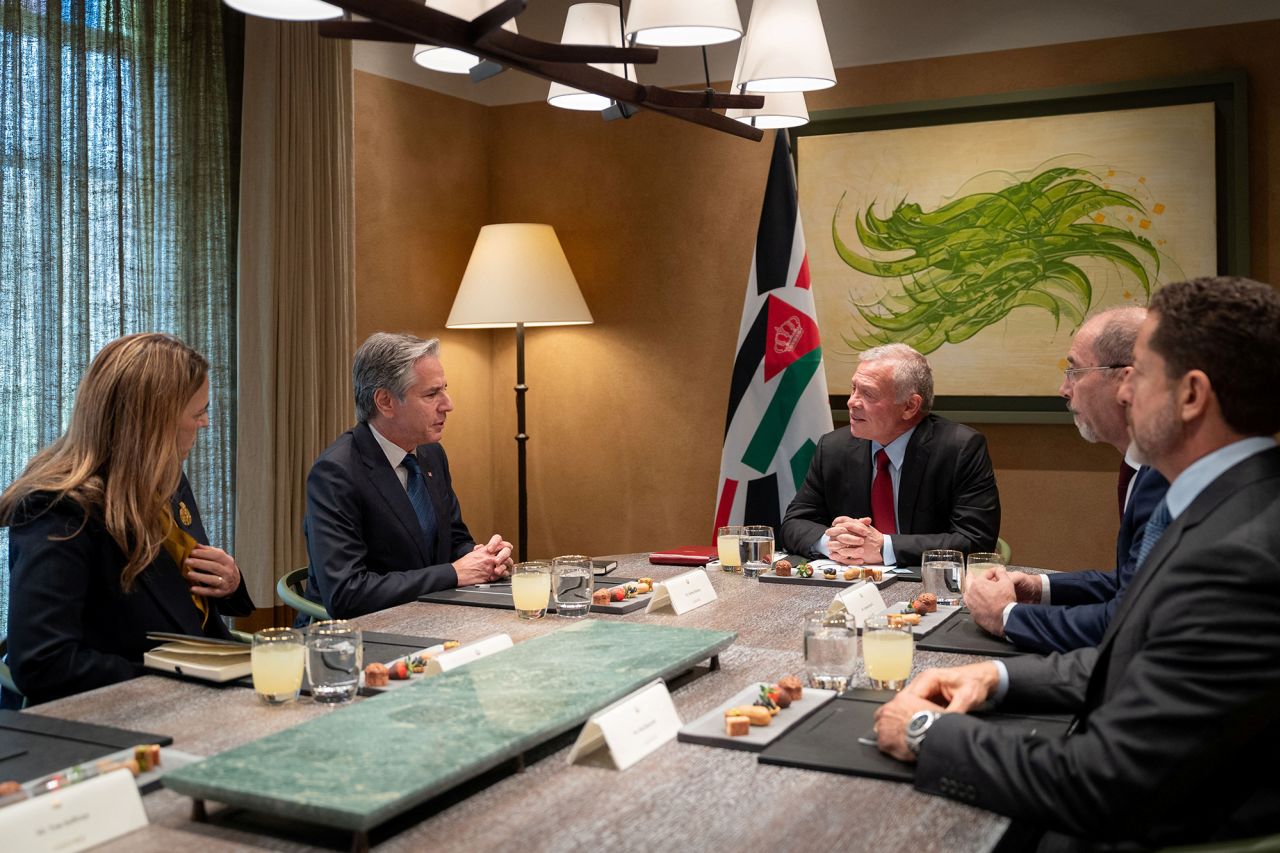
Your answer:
[781,343,1000,565]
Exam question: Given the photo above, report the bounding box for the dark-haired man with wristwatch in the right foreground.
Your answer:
[876,278,1280,847]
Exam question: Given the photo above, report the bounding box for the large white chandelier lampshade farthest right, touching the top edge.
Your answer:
[737,0,836,92]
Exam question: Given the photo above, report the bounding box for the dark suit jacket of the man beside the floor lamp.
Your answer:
[302,424,475,619]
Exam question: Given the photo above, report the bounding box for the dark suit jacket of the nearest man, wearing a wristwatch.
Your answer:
[915,448,1280,845]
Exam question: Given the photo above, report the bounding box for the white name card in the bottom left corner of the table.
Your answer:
[0,767,147,853]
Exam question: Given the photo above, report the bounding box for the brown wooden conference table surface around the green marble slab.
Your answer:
[28,555,1009,853]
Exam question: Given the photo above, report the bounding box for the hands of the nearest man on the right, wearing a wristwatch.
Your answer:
[876,661,1000,761]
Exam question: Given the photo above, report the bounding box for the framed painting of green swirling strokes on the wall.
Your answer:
[790,70,1249,423]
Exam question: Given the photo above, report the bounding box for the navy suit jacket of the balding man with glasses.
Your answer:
[1005,465,1169,652]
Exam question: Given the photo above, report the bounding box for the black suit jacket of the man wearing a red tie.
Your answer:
[781,415,1000,566]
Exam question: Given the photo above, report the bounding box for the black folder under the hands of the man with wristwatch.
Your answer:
[759,690,1071,783]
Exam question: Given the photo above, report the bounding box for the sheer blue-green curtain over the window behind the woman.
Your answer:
[0,0,239,634]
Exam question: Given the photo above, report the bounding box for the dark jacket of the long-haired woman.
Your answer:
[9,475,253,704]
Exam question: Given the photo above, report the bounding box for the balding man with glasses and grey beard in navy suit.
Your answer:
[965,307,1169,652]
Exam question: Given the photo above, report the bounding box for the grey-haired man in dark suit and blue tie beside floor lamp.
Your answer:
[303,332,511,619]
